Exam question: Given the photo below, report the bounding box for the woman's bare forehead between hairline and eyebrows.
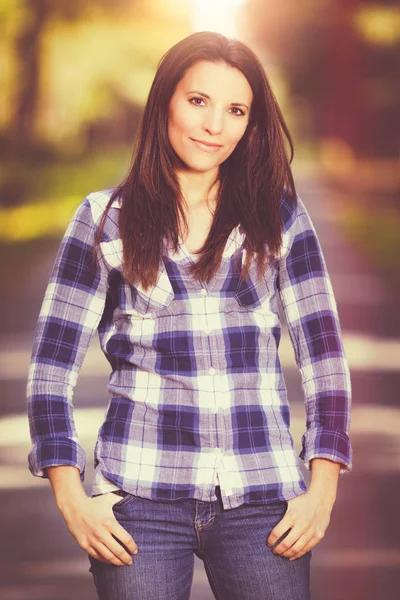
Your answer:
[177,60,253,104]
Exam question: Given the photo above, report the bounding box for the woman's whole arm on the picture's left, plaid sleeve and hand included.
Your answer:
[27,199,137,566]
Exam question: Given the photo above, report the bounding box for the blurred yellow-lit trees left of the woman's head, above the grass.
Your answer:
[0,0,192,206]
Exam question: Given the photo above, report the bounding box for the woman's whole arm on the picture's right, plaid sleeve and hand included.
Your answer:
[268,192,352,560]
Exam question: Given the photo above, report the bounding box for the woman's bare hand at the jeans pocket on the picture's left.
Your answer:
[60,492,138,566]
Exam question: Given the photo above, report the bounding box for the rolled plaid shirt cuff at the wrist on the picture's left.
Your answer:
[28,438,86,482]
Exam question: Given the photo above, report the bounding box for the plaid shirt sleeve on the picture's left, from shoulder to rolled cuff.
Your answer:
[27,198,107,481]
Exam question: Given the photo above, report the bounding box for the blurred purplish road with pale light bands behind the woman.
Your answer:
[0,171,400,600]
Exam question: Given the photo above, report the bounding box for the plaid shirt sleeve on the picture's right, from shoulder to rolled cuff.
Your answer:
[278,196,352,475]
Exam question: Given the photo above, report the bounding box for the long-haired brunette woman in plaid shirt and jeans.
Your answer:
[28,32,351,600]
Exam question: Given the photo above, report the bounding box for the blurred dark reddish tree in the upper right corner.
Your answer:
[246,0,400,157]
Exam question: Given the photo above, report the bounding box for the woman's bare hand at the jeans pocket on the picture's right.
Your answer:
[267,491,333,560]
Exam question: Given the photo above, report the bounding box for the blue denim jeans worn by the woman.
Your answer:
[88,487,312,600]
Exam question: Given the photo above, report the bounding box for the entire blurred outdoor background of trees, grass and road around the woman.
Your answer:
[0,0,400,600]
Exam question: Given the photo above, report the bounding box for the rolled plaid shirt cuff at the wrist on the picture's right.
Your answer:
[299,427,353,475]
